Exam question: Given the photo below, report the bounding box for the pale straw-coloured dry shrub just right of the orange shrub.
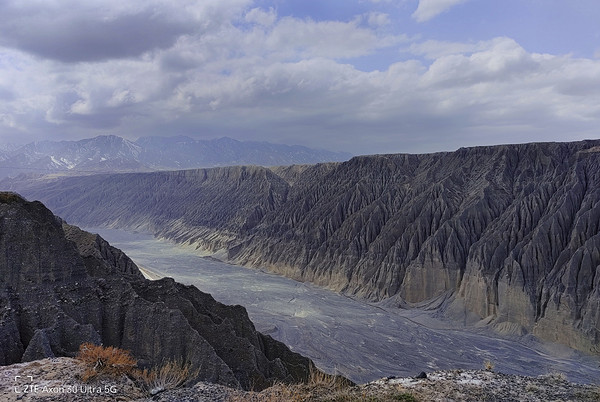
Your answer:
[133,361,199,395]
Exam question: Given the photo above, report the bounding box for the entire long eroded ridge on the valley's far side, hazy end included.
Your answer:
[8,140,600,351]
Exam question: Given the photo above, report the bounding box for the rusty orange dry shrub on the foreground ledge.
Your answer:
[76,343,137,381]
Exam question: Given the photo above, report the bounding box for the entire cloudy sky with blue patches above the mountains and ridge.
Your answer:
[0,0,600,155]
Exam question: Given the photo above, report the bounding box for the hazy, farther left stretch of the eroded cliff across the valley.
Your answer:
[13,166,289,250]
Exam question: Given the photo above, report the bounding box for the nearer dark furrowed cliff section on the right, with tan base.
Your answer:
[238,142,600,350]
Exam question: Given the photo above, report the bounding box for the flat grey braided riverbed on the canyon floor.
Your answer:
[86,228,600,383]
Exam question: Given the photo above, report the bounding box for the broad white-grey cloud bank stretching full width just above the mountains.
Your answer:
[0,28,600,153]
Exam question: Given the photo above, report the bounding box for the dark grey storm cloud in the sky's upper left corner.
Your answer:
[0,3,194,63]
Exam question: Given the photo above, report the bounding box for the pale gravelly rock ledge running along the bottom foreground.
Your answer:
[0,358,600,402]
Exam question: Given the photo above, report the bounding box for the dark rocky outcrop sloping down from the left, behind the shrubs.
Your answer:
[0,193,310,388]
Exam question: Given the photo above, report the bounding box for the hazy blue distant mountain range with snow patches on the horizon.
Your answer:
[0,135,351,178]
